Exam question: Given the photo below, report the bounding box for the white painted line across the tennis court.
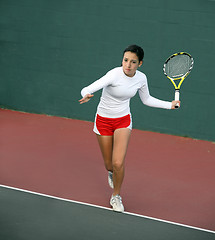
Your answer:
[0,185,215,234]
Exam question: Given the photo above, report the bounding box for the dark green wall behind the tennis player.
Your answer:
[0,0,215,141]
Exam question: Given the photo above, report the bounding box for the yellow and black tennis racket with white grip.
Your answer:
[163,52,194,108]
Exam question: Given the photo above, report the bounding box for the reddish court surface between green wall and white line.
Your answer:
[0,110,215,231]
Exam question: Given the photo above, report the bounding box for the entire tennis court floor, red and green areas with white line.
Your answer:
[0,110,215,240]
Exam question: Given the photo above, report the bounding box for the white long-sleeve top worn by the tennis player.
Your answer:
[81,67,172,118]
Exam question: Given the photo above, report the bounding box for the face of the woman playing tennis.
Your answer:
[122,52,143,77]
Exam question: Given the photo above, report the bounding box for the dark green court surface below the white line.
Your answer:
[0,187,215,240]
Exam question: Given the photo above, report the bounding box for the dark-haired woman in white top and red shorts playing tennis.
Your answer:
[79,45,180,212]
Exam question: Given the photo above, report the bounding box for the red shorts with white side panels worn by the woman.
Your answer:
[93,114,132,136]
